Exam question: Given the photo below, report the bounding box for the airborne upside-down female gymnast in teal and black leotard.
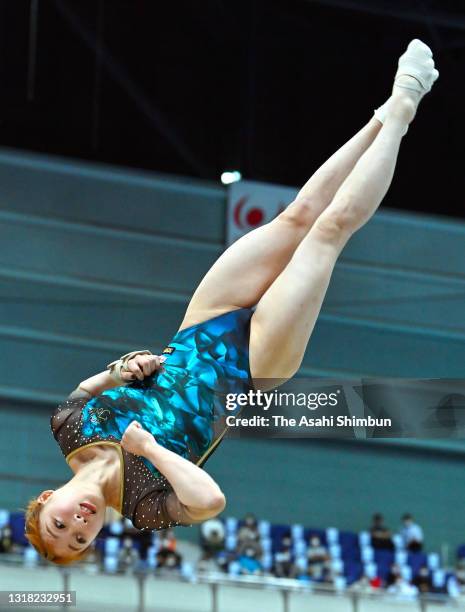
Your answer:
[26,39,439,564]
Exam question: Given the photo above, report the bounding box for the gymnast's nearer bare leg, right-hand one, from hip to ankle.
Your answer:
[250,44,437,382]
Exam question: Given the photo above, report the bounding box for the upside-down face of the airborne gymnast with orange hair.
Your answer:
[38,486,105,558]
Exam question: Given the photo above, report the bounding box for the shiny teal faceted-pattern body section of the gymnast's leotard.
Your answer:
[81,308,253,476]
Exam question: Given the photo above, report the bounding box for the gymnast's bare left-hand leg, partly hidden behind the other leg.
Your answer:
[177,117,382,329]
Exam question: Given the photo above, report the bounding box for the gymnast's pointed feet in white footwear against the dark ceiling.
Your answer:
[375,38,439,133]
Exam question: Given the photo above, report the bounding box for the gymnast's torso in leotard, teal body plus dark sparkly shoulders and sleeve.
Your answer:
[50,308,253,529]
